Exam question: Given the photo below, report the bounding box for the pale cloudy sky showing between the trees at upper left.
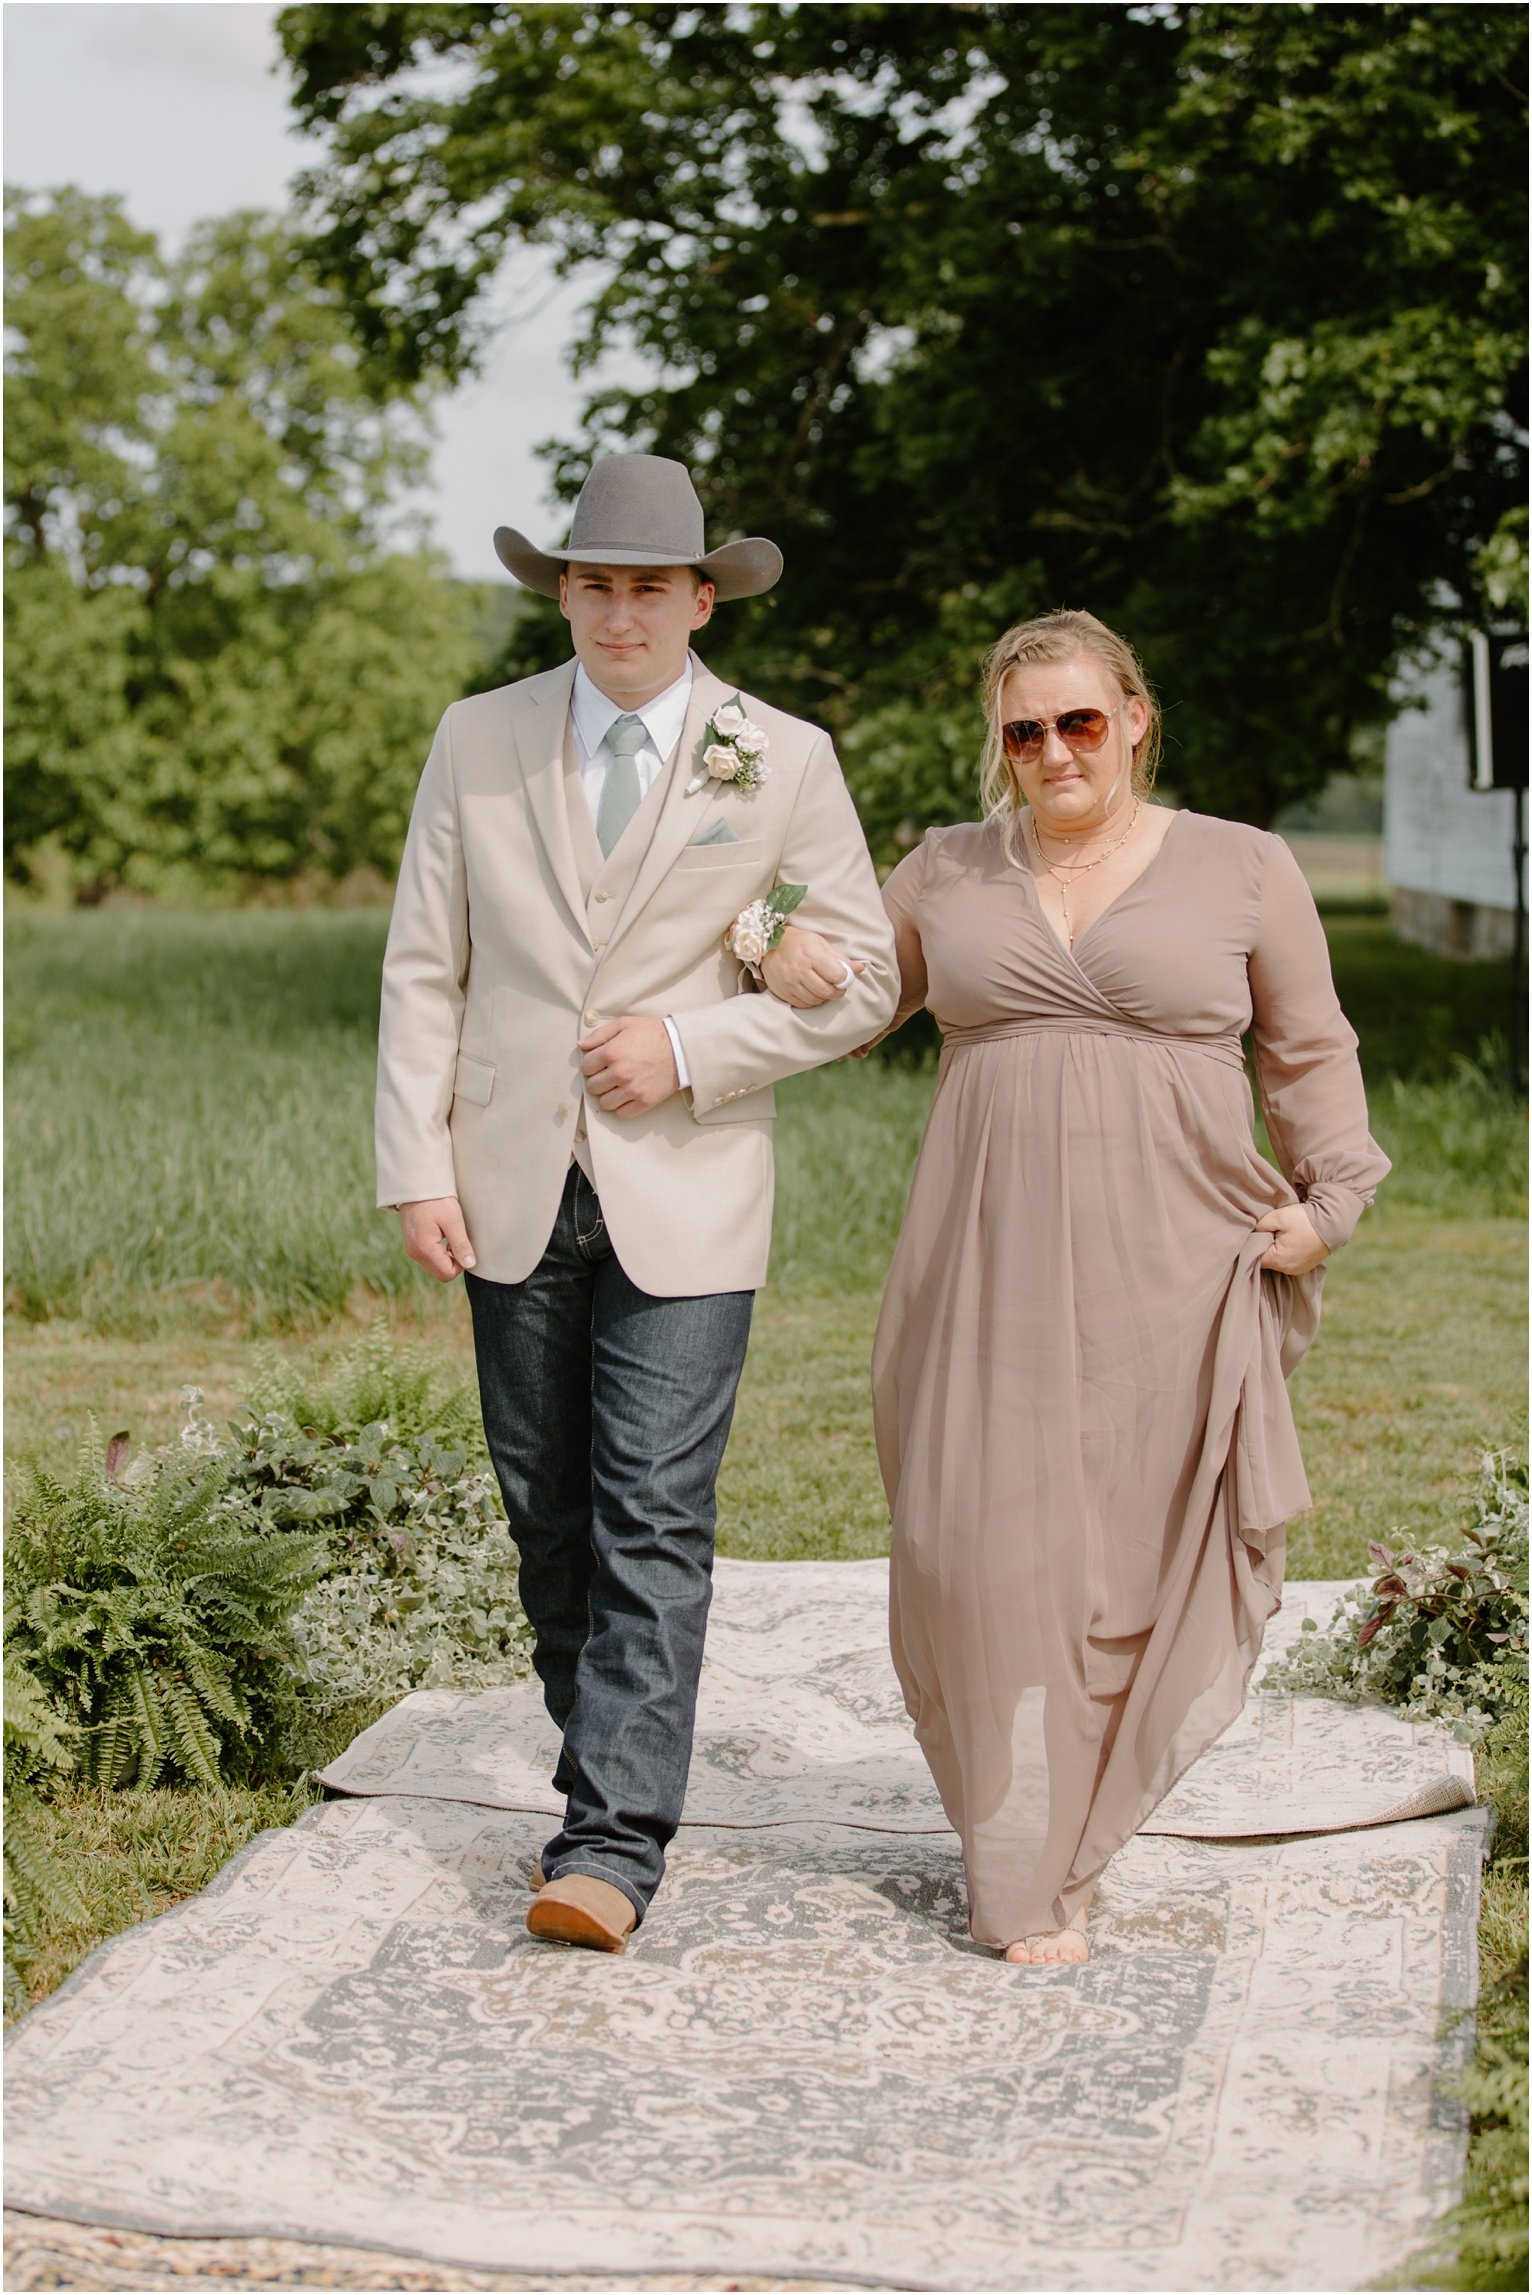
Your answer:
[2,0,628,581]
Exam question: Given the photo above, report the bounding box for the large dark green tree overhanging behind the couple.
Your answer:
[280,0,1525,845]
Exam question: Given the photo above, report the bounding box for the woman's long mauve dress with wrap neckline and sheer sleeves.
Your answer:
[874,812,1388,1946]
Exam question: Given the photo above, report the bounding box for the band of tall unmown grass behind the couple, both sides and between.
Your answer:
[7,911,1525,1338]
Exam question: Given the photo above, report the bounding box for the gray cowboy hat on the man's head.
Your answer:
[495,454,782,599]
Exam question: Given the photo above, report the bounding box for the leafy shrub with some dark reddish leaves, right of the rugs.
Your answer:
[1261,1453,1527,1742]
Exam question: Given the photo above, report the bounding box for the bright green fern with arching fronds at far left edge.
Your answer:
[5,1427,328,1786]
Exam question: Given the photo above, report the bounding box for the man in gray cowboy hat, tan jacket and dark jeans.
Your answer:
[378,454,897,1951]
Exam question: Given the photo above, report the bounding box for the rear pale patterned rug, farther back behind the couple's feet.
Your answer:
[321,1561,1475,1841]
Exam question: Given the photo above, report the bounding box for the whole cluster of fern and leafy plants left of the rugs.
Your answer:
[7,1327,530,1786]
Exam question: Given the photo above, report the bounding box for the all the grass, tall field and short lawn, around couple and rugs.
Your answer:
[7,907,1527,2286]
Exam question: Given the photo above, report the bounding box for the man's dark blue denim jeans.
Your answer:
[466,1164,755,1921]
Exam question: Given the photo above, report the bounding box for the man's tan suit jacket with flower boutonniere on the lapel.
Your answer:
[378,656,899,1297]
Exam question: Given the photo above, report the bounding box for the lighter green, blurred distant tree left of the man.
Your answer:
[5,190,475,900]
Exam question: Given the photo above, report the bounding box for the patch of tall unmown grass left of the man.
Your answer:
[7,911,429,1336]
